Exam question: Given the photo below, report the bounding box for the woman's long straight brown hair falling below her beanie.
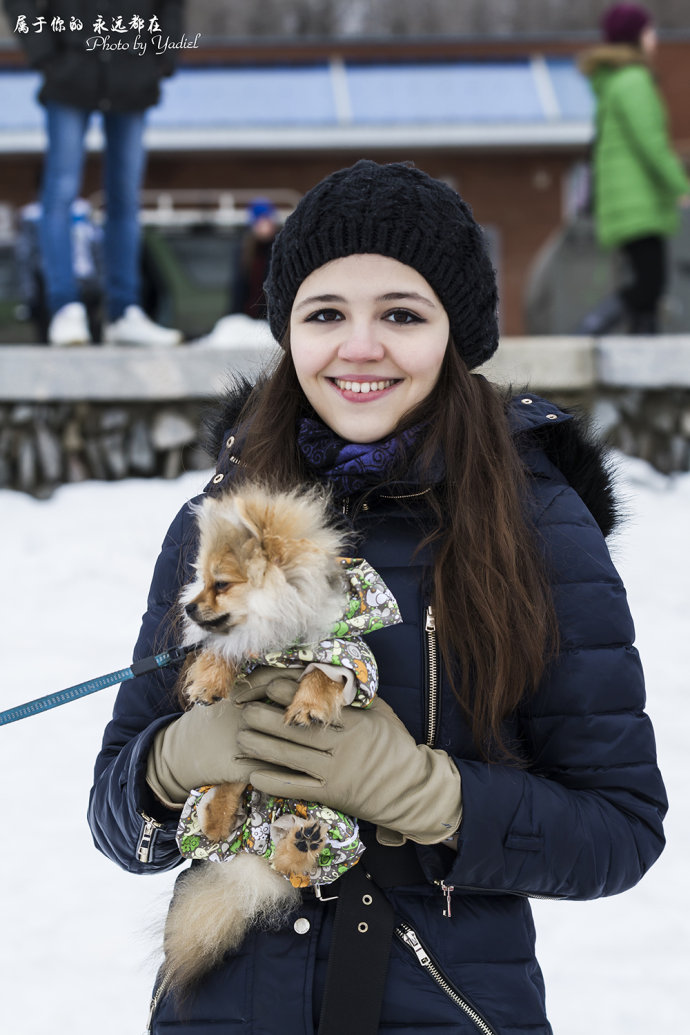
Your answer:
[234,341,558,761]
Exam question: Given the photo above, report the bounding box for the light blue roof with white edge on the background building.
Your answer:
[0,57,593,152]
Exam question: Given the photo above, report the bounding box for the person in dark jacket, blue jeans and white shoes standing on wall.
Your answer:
[4,0,182,346]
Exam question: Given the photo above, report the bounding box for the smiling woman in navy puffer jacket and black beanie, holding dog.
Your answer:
[89,160,666,1035]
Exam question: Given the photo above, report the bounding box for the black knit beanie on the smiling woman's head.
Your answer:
[264,159,499,369]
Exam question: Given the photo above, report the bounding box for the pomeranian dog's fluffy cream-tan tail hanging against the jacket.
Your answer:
[163,852,300,998]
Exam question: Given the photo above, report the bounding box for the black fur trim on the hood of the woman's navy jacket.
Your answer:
[202,376,621,536]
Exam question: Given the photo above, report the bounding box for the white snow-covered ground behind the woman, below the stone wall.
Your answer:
[0,457,690,1035]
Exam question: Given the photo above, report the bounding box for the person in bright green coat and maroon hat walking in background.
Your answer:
[579,3,690,334]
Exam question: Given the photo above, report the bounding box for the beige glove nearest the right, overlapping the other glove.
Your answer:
[237,676,462,845]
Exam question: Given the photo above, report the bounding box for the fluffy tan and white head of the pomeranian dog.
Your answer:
[182,486,343,655]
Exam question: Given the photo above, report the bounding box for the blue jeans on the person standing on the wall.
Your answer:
[40,104,146,321]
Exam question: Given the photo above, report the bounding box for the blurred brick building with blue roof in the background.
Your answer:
[0,25,690,341]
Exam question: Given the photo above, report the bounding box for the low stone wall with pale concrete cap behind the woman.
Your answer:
[0,335,690,496]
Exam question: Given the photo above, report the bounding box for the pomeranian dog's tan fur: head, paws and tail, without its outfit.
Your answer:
[163,483,360,994]
